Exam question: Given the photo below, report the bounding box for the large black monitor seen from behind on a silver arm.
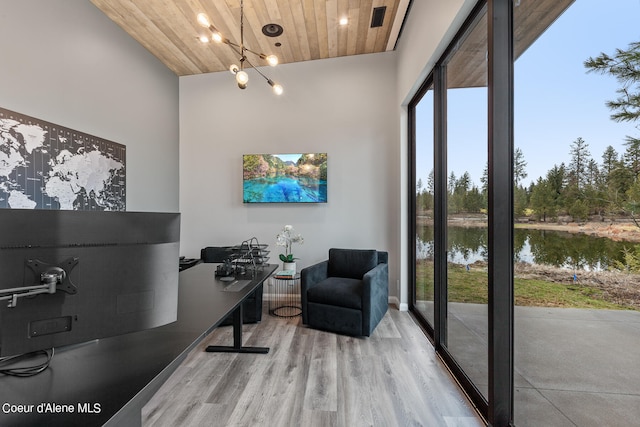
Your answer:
[0,209,180,356]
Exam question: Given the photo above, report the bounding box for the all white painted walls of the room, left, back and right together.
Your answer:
[0,0,475,305]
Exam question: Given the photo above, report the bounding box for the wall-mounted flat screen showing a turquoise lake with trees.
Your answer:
[242,153,327,203]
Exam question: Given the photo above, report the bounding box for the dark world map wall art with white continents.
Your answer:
[0,107,126,211]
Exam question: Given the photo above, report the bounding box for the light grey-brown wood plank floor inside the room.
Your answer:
[142,304,485,427]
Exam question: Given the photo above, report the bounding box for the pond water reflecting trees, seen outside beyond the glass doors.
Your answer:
[416,226,635,271]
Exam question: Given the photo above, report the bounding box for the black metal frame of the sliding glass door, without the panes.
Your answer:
[407,0,514,427]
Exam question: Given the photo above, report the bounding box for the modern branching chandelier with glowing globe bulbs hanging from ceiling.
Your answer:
[197,0,283,95]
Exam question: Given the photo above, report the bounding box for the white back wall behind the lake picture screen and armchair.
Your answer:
[180,52,400,294]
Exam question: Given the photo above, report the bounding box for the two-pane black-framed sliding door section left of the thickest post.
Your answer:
[410,1,488,412]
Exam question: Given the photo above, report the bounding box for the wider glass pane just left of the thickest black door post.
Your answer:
[443,5,488,399]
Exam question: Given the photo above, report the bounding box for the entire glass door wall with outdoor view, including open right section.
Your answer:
[409,0,640,426]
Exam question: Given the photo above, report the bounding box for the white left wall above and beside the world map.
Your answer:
[0,0,179,212]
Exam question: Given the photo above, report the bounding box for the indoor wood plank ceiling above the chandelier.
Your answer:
[91,0,408,76]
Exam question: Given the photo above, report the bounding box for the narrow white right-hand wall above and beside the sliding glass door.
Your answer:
[396,0,477,310]
